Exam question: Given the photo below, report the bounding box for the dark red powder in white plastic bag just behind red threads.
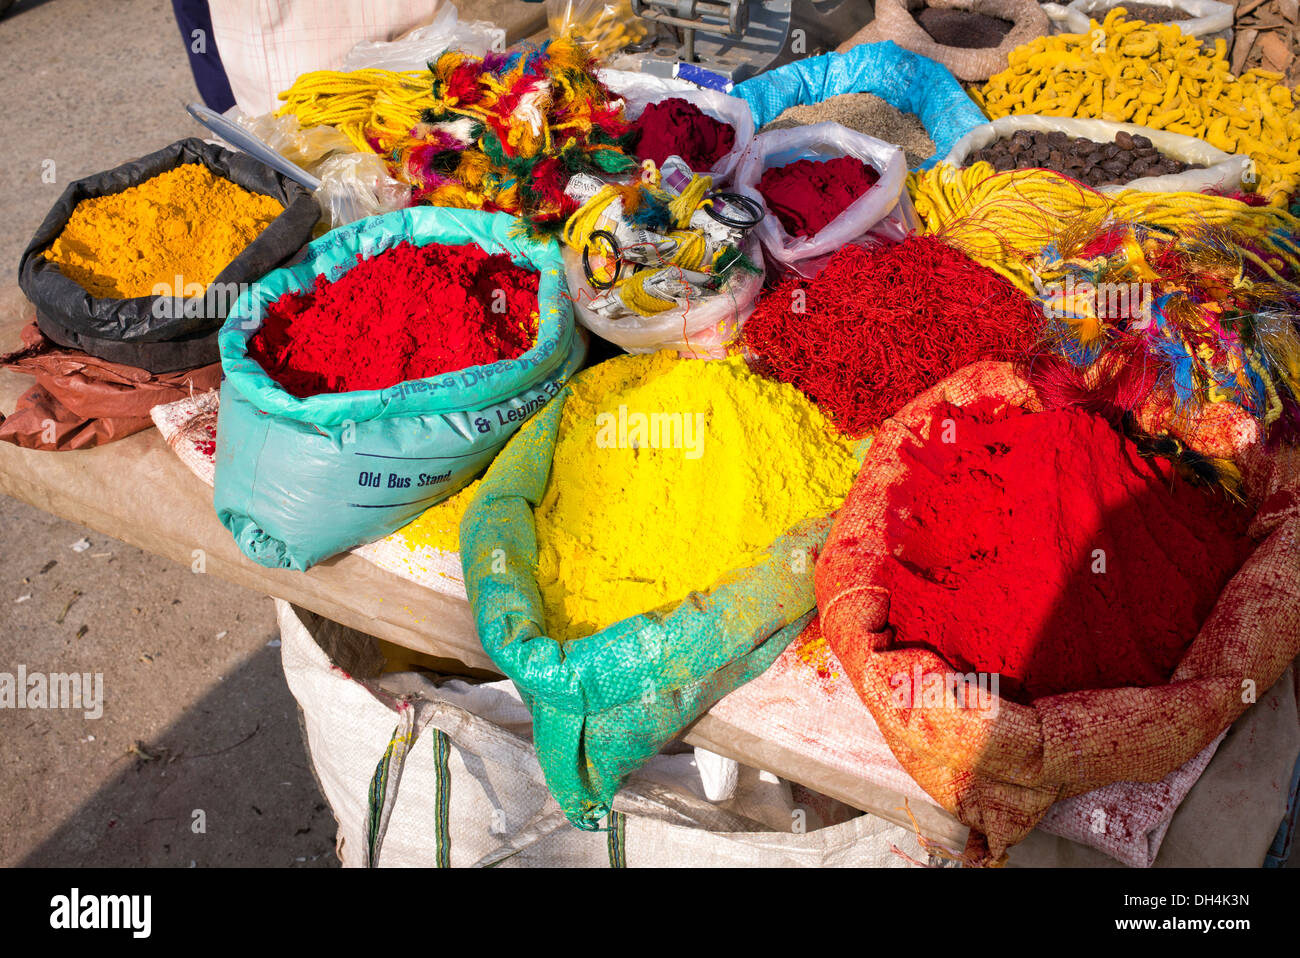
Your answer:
[758,156,880,237]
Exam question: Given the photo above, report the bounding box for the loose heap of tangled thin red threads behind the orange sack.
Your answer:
[742,235,1043,435]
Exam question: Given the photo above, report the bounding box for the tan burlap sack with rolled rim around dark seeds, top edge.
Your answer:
[839,0,1050,81]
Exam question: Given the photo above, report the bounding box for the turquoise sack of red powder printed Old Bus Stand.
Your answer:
[213,207,586,569]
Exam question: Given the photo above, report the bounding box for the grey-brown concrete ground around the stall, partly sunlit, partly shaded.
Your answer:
[0,0,542,867]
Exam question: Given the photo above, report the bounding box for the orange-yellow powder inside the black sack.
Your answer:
[46,162,285,299]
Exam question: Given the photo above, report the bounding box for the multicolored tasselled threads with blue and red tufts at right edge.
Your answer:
[1030,221,1300,443]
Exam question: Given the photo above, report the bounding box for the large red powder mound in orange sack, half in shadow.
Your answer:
[887,400,1253,703]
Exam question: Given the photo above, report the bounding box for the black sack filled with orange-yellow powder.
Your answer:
[18,138,320,373]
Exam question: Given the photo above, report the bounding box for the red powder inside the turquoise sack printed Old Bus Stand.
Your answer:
[248,242,538,399]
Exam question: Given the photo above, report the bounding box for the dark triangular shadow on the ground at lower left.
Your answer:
[20,636,338,867]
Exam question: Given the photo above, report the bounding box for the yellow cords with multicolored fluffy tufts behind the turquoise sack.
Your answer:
[280,39,636,233]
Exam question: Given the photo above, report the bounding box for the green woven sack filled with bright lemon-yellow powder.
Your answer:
[460,352,858,828]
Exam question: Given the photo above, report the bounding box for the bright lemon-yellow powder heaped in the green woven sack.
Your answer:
[536,352,858,641]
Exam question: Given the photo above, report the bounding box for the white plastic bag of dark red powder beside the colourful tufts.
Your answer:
[601,70,754,187]
